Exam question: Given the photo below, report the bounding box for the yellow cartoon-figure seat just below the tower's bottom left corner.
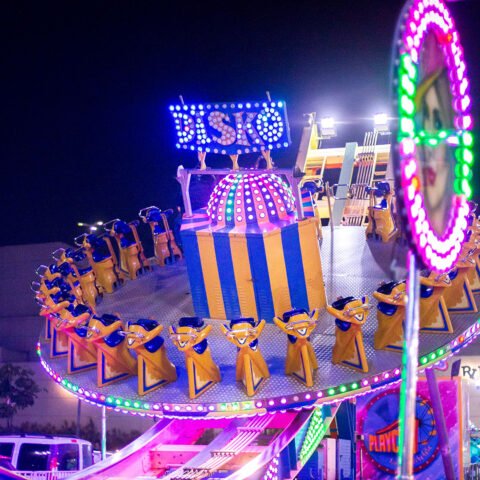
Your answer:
[170,317,221,398]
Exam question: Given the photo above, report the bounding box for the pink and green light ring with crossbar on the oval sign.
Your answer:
[397,0,474,272]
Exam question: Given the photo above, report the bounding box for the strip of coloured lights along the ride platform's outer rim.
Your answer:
[37,319,480,418]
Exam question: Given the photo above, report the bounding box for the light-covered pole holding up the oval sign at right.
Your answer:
[397,251,420,480]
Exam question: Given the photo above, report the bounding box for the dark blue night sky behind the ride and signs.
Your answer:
[0,0,480,245]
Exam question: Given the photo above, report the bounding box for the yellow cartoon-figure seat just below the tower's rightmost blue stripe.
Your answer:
[273,308,319,387]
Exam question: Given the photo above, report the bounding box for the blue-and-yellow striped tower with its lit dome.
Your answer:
[182,173,326,322]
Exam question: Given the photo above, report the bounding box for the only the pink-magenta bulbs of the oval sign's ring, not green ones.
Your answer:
[399,0,473,273]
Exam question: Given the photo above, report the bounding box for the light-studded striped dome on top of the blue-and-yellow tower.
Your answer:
[207,173,295,227]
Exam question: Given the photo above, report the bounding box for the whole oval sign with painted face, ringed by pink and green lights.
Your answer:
[394,0,473,272]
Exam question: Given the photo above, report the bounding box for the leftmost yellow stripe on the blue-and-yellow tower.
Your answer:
[197,232,226,319]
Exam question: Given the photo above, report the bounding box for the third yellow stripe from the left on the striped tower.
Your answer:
[263,230,292,320]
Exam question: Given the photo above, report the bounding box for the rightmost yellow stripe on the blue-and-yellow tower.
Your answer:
[298,219,327,309]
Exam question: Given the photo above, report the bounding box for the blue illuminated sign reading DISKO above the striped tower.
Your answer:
[170,101,291,155]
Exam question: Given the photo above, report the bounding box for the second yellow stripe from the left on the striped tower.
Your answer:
[230,234,258,320]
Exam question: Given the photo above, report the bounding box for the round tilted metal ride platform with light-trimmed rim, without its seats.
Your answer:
[38,227,480,418]
